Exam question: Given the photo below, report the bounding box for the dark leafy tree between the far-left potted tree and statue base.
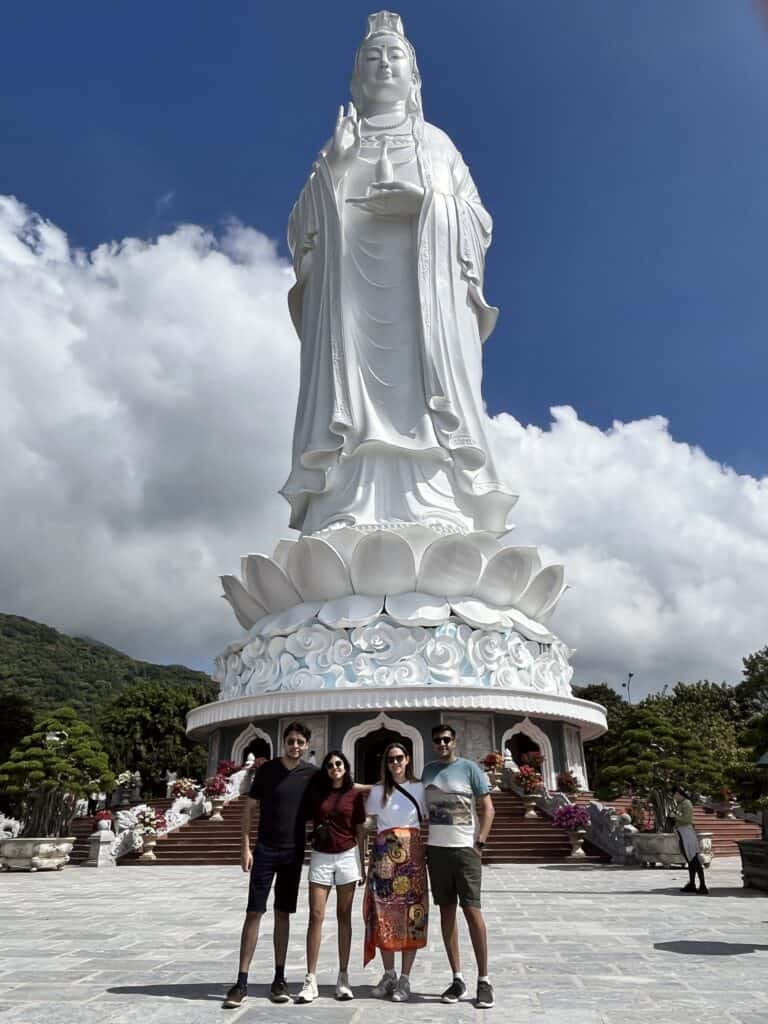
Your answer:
[100,682,216,796]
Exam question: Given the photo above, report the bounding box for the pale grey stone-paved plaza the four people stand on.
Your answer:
[0,858,768,1024]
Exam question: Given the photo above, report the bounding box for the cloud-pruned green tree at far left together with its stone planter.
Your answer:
[0,708,115,871]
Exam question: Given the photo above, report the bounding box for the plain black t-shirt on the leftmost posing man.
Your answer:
[248,758,317,850]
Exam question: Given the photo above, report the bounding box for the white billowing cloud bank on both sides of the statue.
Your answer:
[0,197,768,693]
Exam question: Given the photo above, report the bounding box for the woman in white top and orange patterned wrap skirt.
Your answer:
[362,743,427,1002]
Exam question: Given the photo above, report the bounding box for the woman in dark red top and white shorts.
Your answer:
[296,751,366,1002]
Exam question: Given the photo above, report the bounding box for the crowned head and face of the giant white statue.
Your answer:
[350,10,424,118]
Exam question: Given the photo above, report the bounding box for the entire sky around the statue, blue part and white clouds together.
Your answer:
[0,0,768,695]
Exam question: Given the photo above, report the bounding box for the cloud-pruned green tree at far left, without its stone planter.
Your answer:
[0,708,115,837]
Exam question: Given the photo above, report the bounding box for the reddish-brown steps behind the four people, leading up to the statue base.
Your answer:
[119,793,600,866]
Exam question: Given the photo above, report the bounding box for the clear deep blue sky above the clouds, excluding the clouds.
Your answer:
[6,0,768,476]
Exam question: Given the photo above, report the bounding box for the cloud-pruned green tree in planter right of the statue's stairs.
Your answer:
[598,703,724,831]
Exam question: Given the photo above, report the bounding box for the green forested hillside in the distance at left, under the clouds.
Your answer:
[0,613,217,722]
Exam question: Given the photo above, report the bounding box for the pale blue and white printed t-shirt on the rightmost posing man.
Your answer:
[421,758,490,847]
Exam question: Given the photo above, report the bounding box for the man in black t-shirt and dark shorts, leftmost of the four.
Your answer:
[223,722,317,1008]
